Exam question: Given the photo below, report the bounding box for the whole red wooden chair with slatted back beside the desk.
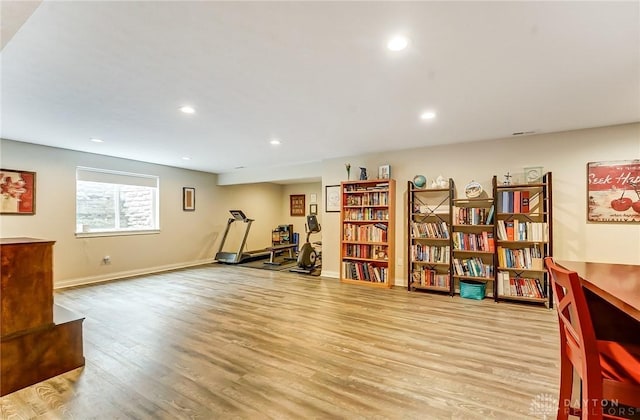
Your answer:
[545,257,640,420]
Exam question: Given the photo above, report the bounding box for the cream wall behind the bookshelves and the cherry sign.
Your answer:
[323,123,640,285]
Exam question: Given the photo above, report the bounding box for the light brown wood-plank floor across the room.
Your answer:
[0,264,558,419]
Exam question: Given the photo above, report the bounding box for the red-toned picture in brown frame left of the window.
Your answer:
[0,169,36,215]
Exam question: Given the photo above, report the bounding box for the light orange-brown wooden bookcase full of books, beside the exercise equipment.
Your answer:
[340,179,396,288]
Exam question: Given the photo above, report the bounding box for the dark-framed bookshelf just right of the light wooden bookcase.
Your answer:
[406,179,455,295]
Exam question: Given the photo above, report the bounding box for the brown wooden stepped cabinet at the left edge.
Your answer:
[0,238,84,396]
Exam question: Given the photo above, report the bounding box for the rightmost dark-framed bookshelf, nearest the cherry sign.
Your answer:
[493,172,553,308]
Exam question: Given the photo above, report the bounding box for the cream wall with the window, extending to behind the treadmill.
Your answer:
[0,140,282,287]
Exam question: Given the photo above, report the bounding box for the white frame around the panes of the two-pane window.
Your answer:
[75,166,160,238]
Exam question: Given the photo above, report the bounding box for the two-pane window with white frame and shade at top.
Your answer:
[76,167,160,235]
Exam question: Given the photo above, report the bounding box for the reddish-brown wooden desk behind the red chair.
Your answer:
[557,261,640,343]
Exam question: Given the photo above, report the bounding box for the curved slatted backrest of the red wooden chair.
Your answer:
[544,257,602,395]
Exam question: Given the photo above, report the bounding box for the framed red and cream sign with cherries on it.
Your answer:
[587,159,640,223]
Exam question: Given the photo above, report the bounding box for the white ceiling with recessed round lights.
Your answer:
[1,0,640,173]
